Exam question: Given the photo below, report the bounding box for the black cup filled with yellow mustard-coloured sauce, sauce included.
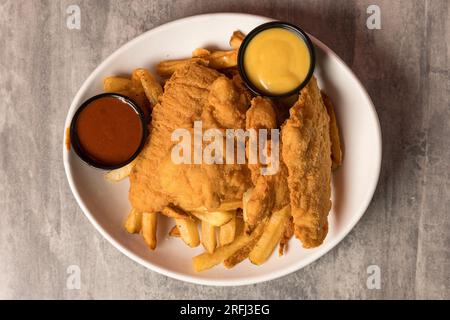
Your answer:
[238,21,316,98]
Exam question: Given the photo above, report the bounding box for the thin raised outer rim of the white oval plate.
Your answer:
[62,12,382,287]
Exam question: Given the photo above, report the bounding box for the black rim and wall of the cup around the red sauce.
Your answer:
[70,93,148,170]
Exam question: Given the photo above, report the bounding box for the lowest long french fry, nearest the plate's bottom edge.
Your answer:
[192,224,263,272]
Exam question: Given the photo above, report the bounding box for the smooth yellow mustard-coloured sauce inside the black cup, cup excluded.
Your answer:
[244,28,311,95]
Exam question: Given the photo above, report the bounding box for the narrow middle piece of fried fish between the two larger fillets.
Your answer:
[244,97,289,231]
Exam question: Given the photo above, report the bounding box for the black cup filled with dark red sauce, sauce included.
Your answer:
[70,93,147,170]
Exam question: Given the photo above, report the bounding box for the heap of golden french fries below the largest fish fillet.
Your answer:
[125,198,292,272]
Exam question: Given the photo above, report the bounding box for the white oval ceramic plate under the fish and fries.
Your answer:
[63,13,381,286]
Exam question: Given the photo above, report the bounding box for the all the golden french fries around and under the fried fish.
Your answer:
[103,31,342,272]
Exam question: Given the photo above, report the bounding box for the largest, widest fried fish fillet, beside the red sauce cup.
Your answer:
[129,63,250,212]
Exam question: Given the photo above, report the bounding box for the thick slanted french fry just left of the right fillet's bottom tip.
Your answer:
[249,205,291,265]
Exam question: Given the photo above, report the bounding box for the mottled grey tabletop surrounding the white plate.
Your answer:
[0,0,450,299]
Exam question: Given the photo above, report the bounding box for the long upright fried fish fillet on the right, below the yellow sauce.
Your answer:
[281,77,331,248]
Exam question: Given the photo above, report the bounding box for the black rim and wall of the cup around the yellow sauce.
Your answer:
[238,21,316,98]
